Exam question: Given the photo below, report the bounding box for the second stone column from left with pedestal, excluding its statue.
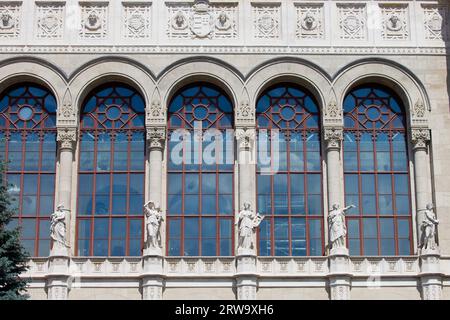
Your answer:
[141,127,166,300]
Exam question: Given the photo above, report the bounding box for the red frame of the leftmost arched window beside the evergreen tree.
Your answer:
[0,83,57,256]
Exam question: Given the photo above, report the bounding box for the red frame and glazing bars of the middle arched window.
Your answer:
[166,82,235,256]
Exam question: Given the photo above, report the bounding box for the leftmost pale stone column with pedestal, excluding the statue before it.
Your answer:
[46,128,77,300]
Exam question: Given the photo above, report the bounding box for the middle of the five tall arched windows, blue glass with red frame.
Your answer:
[167,83,234,256]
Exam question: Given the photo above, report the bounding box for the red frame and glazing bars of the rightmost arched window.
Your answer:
[343,84,413,255]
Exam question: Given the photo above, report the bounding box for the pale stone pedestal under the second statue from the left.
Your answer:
[141,248,164,300]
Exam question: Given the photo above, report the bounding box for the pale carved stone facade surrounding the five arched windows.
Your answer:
[0,0,450,299]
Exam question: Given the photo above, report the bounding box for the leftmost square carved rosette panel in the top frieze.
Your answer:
[36,3,65,39]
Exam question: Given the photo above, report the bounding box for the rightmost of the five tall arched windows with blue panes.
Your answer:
[344,85,412,255]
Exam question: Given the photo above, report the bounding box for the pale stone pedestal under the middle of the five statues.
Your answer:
[236,249,257,300]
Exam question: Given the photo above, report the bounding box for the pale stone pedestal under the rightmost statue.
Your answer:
[420,249,442,300]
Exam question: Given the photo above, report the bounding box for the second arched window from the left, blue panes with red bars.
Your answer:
[77,83,145,256]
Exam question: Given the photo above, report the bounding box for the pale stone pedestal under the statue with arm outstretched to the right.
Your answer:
[328,248,351,300]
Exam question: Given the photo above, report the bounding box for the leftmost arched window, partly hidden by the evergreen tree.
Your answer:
[0,84,56,256]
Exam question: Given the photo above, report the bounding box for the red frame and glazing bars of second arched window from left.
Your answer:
[75,83,147,256]
